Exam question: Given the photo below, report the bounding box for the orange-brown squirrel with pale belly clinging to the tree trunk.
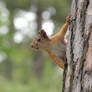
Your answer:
[31,15,71,69]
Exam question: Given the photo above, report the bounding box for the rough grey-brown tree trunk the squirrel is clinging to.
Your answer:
[63,0,92,92]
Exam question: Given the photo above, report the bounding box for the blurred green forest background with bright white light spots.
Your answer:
[0,0,71,92]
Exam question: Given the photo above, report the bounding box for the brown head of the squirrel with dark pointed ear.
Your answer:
[31,29,50,50]
